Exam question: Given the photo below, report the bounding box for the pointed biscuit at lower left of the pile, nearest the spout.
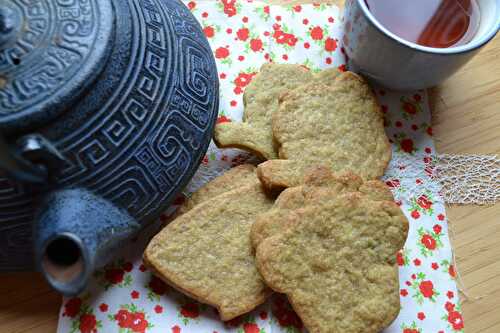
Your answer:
[144,184,273,320]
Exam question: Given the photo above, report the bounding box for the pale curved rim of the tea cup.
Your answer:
[356,0,500,55]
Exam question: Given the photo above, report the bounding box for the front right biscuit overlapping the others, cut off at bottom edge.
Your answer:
[256,192,408,333]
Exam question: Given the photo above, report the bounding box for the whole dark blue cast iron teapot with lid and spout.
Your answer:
[0,0,218,295]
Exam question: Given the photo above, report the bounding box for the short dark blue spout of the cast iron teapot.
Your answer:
[34,189,140,296]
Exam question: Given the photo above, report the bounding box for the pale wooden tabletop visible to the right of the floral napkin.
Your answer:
[430,35,500,333]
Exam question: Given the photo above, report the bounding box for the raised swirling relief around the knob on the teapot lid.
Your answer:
[0,0,109,119]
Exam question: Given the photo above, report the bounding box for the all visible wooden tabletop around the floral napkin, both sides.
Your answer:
[0,0,500,333]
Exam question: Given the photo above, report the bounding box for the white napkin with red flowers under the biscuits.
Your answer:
[58,0,464,333]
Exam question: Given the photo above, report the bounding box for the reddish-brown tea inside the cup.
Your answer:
[365,0,480,48]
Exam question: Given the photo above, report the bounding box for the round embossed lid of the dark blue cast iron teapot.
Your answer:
[0,0,115,134]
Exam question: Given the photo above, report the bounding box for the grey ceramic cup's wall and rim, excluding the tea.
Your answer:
[343,0,500,90]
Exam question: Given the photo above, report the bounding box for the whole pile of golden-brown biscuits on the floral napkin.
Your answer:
[144,64,408,333]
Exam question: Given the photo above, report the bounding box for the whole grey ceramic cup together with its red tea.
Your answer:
[343,0,500,90]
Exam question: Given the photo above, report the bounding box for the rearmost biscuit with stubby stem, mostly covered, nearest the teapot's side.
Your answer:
[214,64,313,159]
